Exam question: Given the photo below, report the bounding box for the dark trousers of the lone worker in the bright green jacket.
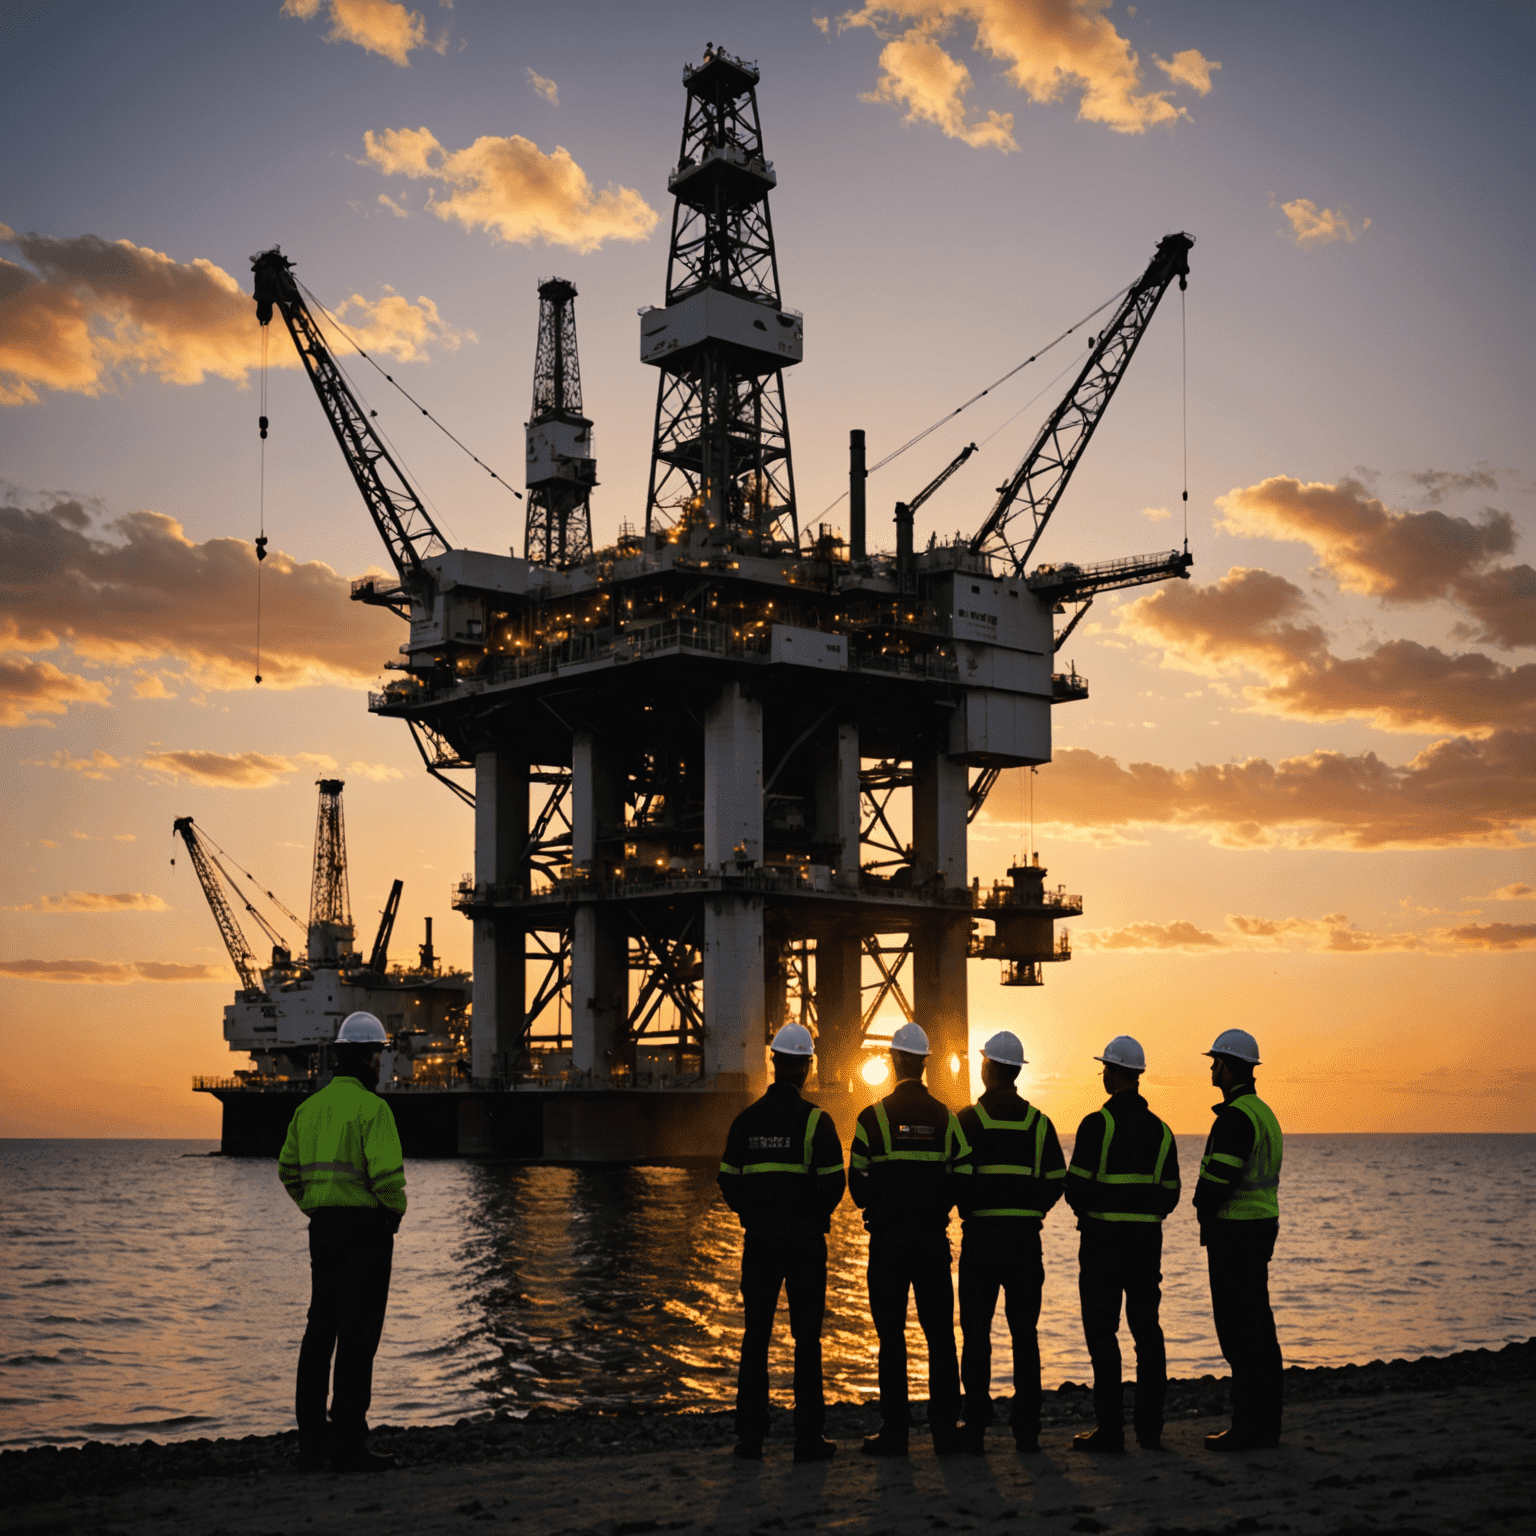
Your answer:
[293,1210,395,1456]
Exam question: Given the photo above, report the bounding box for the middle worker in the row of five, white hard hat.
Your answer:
[957,1029,1066,1456]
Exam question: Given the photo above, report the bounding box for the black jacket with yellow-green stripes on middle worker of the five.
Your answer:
[955,1084,1066,1230]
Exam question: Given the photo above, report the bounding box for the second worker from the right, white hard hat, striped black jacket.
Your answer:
[1066,1035,1180,1452]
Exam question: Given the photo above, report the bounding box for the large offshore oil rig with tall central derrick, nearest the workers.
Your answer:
[221,45,1193,1160]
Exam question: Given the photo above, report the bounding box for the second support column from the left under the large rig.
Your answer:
[570,731,630,1078]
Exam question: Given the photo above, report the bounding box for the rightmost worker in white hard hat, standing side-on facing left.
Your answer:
[1195,1029,1284,1450]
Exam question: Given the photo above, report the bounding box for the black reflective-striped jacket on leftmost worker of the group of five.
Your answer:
[720,1083,846,1238]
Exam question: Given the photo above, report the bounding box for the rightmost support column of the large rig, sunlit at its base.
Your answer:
[912,750,971,1106]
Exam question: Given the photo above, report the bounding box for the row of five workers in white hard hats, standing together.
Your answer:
[720,1023,1283,1461]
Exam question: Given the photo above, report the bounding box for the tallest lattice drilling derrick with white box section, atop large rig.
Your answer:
[641,43,805,553]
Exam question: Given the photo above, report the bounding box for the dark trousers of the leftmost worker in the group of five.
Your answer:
[736,1232,826,1441]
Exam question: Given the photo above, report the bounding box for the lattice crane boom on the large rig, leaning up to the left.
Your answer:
[250,246,449,599]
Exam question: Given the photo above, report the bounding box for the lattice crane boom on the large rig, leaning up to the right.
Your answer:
[971,233,1195,576]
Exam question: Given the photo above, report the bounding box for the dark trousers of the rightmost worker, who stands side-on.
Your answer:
[1204,1221,1284,1441]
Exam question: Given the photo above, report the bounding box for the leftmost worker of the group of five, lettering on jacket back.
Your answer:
[720,1025,846,1461]
